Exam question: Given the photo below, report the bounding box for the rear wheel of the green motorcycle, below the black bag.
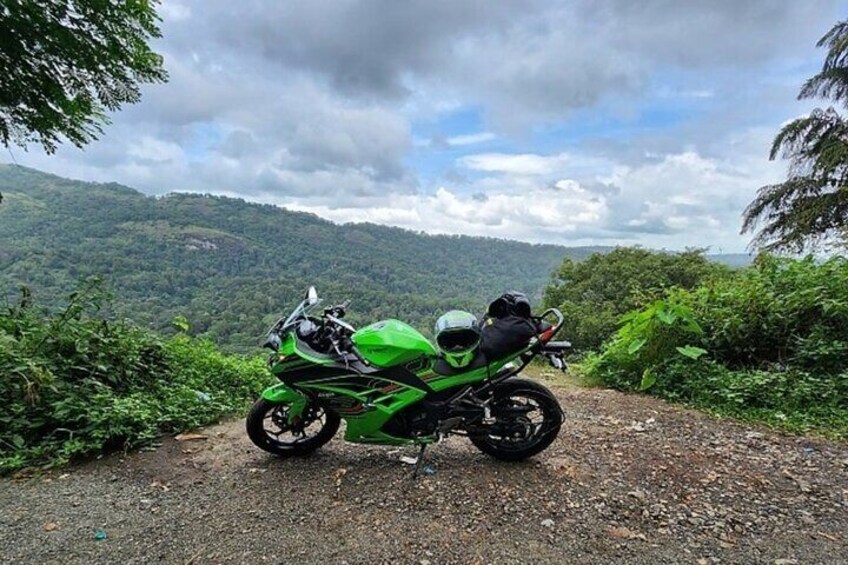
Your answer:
[469,379,562,461]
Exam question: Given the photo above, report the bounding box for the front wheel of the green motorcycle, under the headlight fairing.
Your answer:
[246,398,341,457]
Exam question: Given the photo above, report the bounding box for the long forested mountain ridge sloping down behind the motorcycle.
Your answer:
[0,165,604,349]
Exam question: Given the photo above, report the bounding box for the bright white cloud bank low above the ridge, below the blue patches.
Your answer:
[227,134,779,250]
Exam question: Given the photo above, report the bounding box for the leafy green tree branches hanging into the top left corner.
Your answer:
[0,0,167,153]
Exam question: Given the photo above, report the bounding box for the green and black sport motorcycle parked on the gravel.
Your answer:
[247,288,570,473]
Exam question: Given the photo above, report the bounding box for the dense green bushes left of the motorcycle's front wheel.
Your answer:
[0,280,269,472]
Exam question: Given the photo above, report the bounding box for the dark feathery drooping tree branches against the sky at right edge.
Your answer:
[742,20,848,252]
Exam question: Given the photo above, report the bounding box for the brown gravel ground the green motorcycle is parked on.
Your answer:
[0,382,848,565]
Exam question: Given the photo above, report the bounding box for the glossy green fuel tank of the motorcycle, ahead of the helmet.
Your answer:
[353,320,436,367]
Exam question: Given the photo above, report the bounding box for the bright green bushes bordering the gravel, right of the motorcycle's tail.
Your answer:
[585,256,848,436]
